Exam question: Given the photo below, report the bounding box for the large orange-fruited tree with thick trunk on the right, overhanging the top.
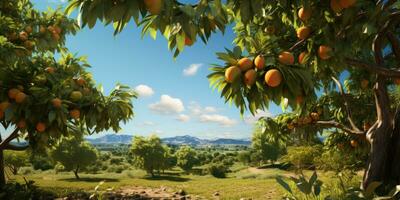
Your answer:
[67,0,400,187]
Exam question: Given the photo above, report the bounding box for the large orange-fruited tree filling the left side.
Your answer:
[0,0,136,187]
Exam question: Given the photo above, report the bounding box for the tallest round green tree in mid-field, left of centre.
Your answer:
[131,135,169,177]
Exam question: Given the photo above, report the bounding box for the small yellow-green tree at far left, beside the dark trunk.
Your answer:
[4,151,29,175]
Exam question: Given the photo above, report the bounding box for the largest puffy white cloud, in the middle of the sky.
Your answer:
[149,94,185,115]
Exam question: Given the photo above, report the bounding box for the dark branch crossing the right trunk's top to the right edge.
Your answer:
[345,58,400,78]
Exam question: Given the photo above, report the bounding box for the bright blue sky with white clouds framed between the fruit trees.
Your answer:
[33,0,280,138]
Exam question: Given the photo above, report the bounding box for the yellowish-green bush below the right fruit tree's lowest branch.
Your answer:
[282,145,322,169]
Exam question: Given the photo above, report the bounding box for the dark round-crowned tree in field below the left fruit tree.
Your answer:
[50,137,99,179]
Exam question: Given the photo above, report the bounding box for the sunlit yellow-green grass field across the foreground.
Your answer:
[6,167,362,199]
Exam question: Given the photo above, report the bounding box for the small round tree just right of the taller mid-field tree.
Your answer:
[175,146,198,172]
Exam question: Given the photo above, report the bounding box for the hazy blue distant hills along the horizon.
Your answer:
[86,134,250,146]
